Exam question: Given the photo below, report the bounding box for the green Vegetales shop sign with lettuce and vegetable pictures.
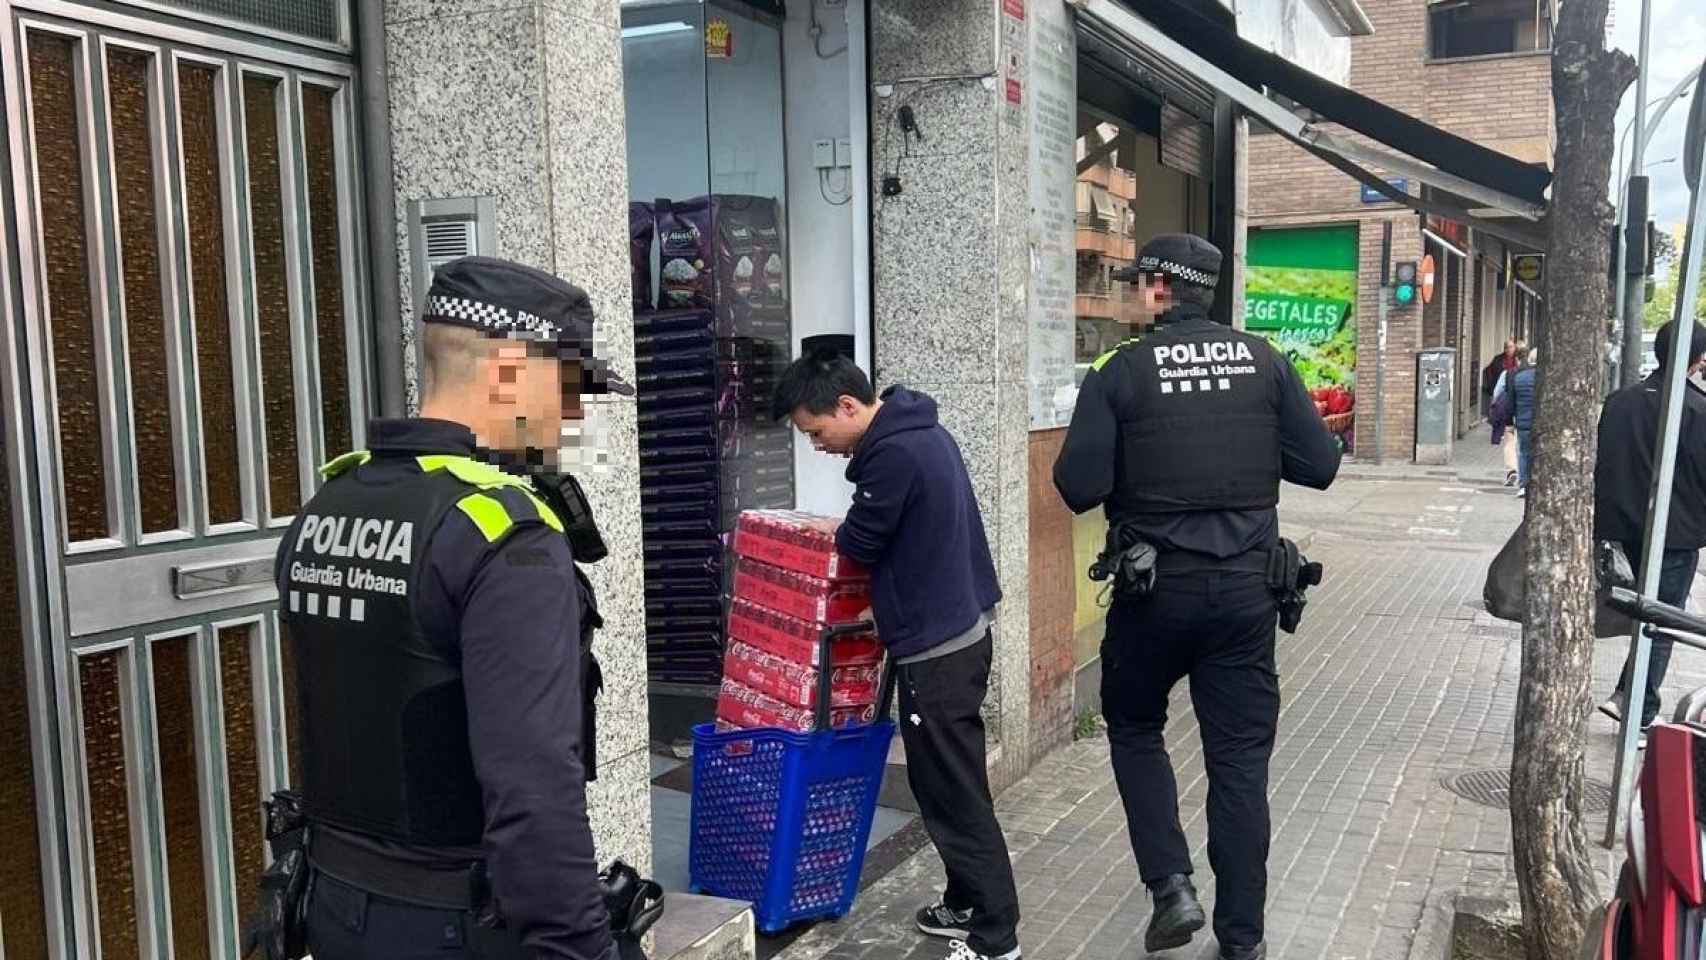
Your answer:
[1244,227,1360,450]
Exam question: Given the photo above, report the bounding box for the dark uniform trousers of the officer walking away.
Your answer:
[1102,562,1280,946]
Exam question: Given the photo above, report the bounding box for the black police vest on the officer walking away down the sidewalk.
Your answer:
[1109,324,1280,518]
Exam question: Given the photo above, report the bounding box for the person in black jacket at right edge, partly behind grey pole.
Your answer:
[1593,322,1706,732]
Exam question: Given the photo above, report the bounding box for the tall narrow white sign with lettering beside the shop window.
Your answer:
[1027,0,1078,430]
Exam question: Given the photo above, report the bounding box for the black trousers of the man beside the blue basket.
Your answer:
[896,634,1018,957]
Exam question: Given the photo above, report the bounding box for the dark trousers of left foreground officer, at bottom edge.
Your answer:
[309,870,529,960]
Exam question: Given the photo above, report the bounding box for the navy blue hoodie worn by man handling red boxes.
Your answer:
[836,387,1001,658]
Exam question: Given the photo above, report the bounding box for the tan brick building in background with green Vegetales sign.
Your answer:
[1245,0,1554,462]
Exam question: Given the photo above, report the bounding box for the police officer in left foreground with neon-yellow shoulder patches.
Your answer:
[278,257,631,960]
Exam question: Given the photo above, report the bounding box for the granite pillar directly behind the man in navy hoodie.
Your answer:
[870,0,1036,788]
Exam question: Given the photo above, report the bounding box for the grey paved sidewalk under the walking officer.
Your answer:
[781,481,1706,960]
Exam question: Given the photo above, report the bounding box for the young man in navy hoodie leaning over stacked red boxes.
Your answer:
[771,353,1018,960]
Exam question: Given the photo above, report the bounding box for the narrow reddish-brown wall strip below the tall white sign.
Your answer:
[1029,430,1076,755]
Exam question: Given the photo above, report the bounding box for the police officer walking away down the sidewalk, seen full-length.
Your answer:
[1054,234,1339,960]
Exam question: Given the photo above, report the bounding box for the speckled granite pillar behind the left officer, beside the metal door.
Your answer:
[386,0,652,871]
